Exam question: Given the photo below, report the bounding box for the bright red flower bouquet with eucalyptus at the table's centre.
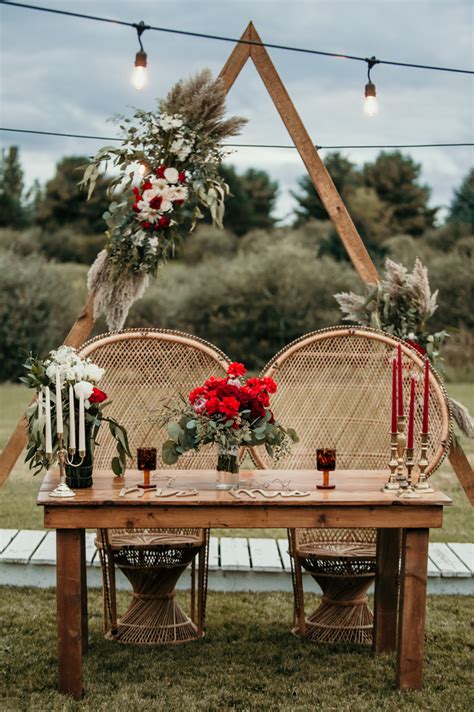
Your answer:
[162,363,298,465]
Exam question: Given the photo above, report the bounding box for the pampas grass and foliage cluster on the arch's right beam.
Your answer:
[334,258,474,438]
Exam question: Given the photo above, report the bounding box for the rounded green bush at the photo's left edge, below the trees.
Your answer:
[0,252,85,380]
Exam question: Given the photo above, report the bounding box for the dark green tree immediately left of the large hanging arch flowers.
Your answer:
[36,156,111,235]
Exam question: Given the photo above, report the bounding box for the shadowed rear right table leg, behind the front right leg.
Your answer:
[372,529,401,654]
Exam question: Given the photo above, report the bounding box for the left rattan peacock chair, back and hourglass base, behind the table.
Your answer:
[81,329,229,645]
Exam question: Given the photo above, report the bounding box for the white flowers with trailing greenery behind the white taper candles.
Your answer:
[20,345,131,475]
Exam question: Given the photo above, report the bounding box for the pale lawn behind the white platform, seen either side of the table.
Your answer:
[0,383,474,542]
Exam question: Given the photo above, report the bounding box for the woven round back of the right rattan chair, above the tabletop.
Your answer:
[252,327,451,479]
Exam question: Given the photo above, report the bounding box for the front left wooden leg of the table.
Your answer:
[56,529,84,700]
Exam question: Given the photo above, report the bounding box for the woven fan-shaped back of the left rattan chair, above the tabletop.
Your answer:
[80,329,229,469]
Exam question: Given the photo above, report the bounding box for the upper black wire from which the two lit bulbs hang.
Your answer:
[0,0,474,74]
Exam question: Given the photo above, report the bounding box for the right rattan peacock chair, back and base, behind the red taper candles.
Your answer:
[252,327,451,644]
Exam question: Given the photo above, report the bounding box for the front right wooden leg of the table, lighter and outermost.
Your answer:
[397,529,429,691]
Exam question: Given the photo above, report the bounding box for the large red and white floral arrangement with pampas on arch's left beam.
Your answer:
[81,69,246,329]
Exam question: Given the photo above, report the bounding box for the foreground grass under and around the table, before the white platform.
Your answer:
[0,588,474,712]
